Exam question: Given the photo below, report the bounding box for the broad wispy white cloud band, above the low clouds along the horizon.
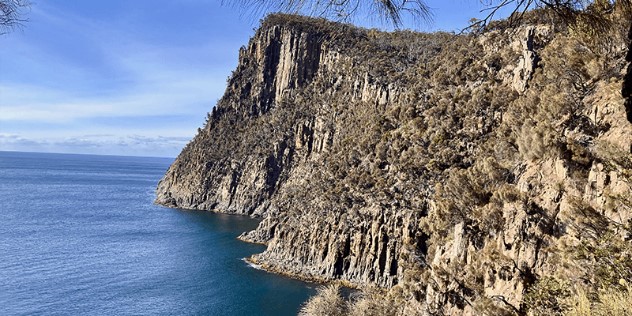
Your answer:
[0,75,225,123]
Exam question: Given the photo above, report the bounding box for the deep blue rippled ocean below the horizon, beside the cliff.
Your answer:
[0,152,314,315]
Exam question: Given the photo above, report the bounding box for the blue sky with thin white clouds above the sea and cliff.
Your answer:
[0,0,512,157]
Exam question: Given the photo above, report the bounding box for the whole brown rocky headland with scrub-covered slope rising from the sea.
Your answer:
[157,14,632,315]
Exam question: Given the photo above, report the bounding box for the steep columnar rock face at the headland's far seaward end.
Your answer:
[157,20,324,215]
